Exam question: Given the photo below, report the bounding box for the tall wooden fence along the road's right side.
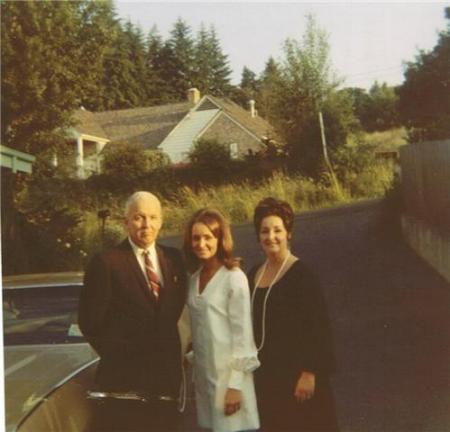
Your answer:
[400,139,450,233]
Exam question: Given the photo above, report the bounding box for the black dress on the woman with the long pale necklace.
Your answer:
[248,260,338,432]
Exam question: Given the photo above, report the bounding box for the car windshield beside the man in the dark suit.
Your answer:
[3,286,83,345]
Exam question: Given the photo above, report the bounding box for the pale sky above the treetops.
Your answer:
[115,0,450,89]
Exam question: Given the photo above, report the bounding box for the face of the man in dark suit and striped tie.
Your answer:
[125,198,162,249]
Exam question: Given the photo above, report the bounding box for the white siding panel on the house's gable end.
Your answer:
[158,109,219,163]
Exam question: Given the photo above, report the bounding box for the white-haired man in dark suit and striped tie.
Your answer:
[79,192,186,432]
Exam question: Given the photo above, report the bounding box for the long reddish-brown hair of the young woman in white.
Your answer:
[183,208,240,271]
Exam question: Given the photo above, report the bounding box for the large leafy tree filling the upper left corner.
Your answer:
[1,1,84,154]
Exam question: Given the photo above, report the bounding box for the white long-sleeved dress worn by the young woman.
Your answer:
[187,266,259,432]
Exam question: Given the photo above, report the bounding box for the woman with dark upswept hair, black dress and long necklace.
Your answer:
[248,198,338,432]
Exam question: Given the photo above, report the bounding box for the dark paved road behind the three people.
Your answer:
[162,201,450,432]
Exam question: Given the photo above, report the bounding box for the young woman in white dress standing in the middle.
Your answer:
[183,209,259,432]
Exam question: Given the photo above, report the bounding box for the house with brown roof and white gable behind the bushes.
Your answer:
[71,89,275,177]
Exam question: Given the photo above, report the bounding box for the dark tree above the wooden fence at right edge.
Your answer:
[399,7,450,141]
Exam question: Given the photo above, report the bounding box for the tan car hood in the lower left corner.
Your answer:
[4,343,97,431]
